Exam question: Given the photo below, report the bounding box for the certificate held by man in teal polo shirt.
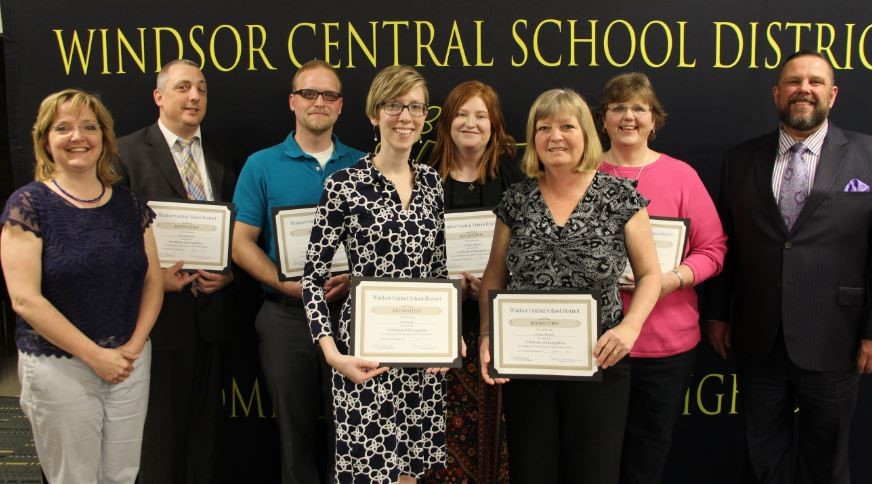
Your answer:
[273,205,348,281]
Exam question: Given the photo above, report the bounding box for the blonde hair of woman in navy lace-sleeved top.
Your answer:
[32,89,120,185]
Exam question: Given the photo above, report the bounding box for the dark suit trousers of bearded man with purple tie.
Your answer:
[737,335,859,484]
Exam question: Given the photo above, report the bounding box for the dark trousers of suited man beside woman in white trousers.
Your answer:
[139,340,222,484]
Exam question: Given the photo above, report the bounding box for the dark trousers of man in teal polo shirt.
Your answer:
[255,298,333,484]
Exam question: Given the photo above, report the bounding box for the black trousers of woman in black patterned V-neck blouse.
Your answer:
[503,358,630,484]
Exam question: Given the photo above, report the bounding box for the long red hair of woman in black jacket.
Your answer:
[430,81,515,183]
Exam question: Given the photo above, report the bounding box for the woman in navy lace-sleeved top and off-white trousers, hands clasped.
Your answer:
[0,89,163,483]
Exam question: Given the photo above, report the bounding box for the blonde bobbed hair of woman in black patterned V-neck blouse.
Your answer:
[521,88,603,178]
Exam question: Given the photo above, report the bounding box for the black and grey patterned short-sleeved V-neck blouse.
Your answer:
[494,172,648,330]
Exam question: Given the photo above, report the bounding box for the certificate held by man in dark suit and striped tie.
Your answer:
[148,200,234,272]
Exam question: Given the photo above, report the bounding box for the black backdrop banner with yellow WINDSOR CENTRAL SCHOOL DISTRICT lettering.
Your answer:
[2,0,872,483]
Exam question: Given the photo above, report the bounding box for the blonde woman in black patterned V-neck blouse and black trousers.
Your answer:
[479,89,660,484]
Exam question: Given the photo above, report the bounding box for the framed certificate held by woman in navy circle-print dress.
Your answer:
[350,277,461,368]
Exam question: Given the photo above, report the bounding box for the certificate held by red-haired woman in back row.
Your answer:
[445,209,497,278]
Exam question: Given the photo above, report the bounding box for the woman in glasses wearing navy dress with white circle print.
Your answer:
[303,66,447,483]
